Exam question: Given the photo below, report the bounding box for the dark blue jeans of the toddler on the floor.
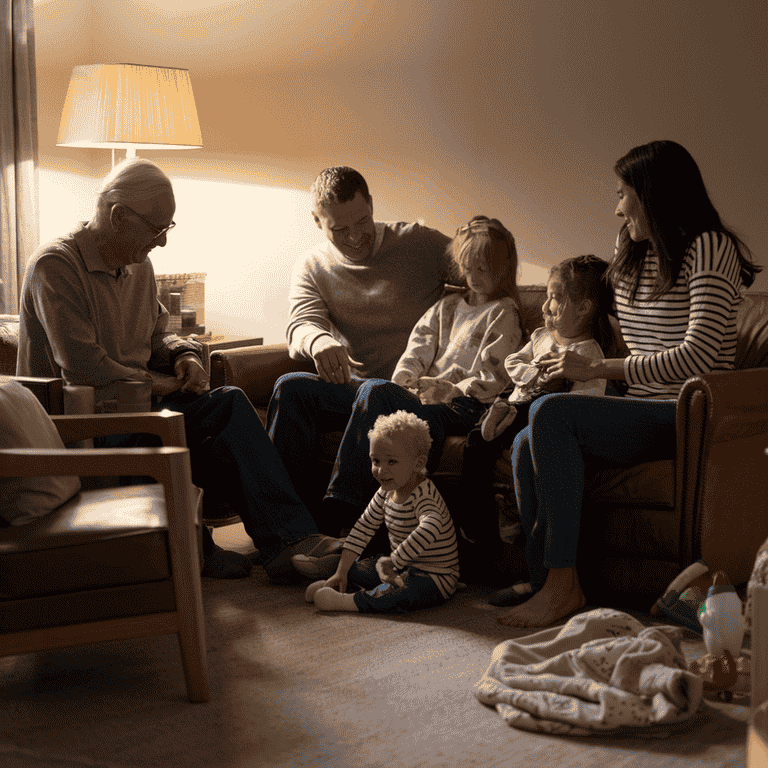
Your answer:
[347,554,446,613]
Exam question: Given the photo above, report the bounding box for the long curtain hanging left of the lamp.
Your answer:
[0,0,40,314]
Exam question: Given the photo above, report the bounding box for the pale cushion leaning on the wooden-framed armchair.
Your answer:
[0,378,80,525]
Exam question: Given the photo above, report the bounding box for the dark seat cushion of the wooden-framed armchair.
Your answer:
[0,484,170,600]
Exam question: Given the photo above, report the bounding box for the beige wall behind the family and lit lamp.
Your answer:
[35,0,768,341]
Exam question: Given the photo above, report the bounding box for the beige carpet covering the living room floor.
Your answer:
[0,525,749,768]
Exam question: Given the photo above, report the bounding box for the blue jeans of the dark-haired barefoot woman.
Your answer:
[511,394,677,590]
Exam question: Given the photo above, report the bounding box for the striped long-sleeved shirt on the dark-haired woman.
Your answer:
[614,232,742,399]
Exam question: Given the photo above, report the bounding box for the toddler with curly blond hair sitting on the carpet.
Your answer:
[302,410,459,613]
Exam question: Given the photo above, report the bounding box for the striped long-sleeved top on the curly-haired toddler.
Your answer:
[344,479,459,598]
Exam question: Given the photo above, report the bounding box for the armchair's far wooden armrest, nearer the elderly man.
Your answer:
[51,410,187,448]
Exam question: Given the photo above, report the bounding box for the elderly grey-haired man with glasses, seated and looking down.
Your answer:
[16,158,342,578]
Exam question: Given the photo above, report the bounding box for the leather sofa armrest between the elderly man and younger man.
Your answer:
[211,344,315,408]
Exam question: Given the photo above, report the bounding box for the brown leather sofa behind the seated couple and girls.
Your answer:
[211,286,768,608]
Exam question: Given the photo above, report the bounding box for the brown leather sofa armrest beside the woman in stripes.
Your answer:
[676,368,768,584]
